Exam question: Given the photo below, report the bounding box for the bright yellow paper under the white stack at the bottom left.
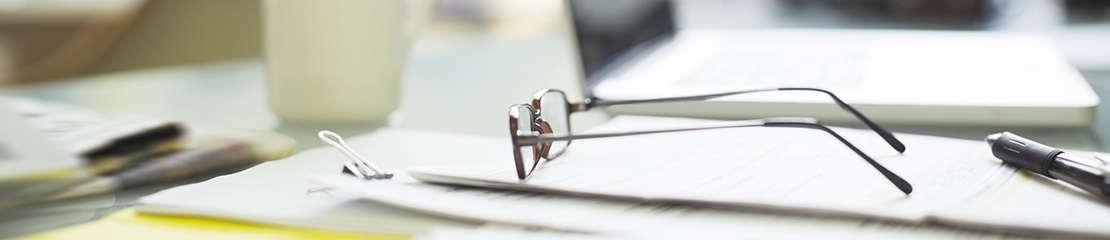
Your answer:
[20,209,408,240]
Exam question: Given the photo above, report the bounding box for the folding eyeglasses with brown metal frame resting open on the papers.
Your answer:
[508,88,914,194]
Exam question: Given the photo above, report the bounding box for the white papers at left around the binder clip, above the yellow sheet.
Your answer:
[138,129,490,234]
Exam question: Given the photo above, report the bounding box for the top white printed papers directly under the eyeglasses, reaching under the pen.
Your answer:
[407,117,1110,236]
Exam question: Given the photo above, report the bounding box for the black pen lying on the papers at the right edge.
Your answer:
[987,132,1110,197]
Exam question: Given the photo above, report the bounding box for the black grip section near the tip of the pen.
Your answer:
[990,132,1063,178]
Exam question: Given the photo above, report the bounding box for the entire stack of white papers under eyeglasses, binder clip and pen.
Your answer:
[138,117,1110,239]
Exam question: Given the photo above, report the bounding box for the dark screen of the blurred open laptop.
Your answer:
[567,0,675,86]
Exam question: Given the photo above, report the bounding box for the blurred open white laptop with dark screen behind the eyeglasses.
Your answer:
[565,0,1099,127]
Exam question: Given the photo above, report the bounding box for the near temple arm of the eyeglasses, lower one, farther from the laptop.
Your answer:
[517,118,914,194]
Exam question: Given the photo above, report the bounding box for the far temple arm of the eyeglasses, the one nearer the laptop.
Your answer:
[571,88,906,152]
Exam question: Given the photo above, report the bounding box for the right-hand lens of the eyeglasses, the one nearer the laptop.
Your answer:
[538,91,571,159]
